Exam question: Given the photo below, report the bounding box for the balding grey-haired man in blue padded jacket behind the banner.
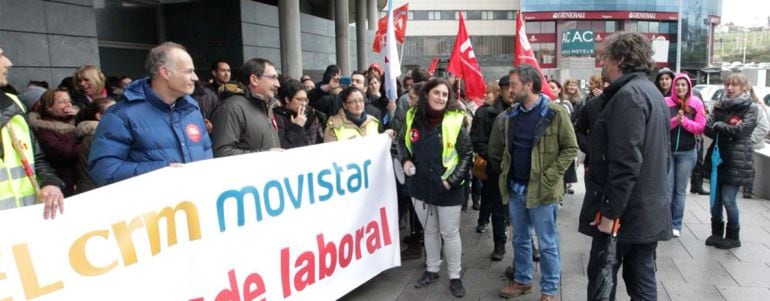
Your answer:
[88,42,213,186]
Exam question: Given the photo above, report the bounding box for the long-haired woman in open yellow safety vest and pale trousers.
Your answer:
[398,78,473,297]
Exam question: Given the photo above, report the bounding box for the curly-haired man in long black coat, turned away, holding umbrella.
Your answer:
[579,33,672,300]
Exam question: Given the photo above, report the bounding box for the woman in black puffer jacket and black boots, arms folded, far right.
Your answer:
[705,73,759,249]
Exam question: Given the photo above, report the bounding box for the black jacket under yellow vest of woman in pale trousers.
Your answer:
[398,111,473,206]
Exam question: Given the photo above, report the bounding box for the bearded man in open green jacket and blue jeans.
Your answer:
[487,65,578,301]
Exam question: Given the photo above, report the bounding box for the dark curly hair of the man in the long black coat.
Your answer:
[601,32,654,74]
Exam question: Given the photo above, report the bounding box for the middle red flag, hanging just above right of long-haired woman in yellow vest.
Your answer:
[447,11,487,106]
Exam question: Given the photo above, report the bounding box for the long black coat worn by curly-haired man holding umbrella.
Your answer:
[578,72,672,243]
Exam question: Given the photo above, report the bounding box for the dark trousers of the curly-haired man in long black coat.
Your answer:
[586,235,658,301]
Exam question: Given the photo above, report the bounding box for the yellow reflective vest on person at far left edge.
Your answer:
[0,94,35,210]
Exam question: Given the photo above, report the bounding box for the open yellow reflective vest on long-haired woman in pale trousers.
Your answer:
[404,108,465,180]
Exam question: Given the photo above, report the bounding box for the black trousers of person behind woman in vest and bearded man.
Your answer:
[479,174,508,244]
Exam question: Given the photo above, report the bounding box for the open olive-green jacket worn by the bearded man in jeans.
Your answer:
[487,96,578,208]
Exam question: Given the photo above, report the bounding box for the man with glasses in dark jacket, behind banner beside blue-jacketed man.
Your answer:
[211,58,281,157]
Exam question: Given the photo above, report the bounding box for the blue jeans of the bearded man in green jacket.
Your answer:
[508,184,561,295]
